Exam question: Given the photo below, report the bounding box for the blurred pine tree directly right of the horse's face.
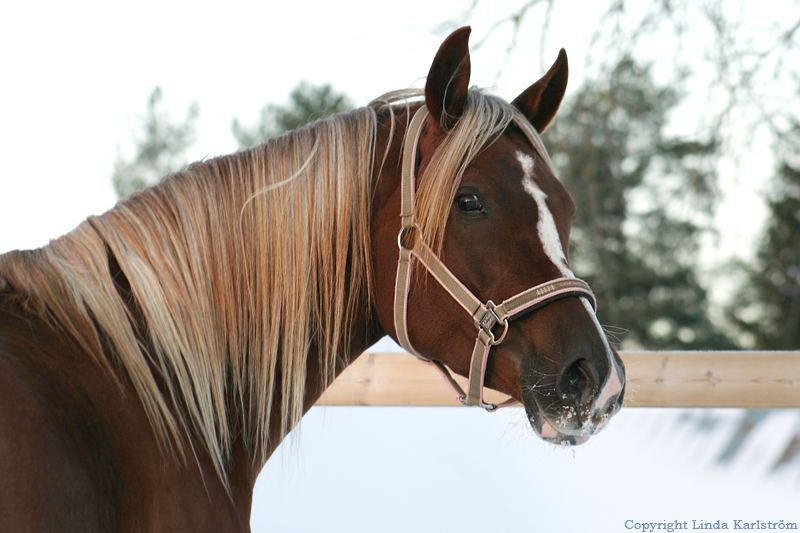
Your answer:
[546,57,732,349]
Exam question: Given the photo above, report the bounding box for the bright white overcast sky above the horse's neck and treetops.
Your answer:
[0,0,587,251]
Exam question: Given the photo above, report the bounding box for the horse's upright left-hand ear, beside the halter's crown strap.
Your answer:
[425,26,472,131]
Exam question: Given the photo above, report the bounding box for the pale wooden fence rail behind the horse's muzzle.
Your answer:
[318,352,800,408]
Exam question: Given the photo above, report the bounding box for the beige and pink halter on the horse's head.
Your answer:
[394,105,597,411]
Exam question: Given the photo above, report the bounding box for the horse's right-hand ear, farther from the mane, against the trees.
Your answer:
[512,48,569,133]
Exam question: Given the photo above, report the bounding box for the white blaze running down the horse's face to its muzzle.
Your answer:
[517,150,622,420]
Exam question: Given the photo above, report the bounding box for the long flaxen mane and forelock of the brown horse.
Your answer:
[0,89,524,480]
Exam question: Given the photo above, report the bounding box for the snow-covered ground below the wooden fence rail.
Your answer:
[251,340,800,533]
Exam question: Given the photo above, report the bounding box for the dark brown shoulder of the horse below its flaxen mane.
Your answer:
[0,294,252,532]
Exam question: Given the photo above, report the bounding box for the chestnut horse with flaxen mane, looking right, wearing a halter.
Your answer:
[0,27,625,532]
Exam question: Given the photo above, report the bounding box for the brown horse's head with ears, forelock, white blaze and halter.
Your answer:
[373,28,625,444]
